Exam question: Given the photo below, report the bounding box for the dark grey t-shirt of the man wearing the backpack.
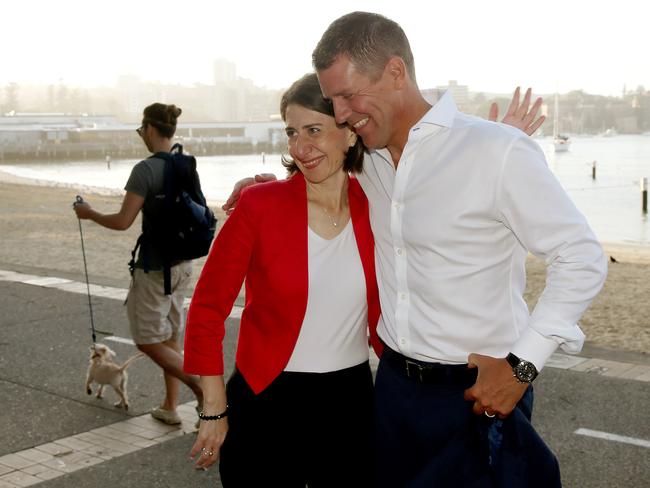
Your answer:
[124,158,165,271]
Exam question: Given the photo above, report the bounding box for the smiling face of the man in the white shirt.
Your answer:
[318,56,395,149]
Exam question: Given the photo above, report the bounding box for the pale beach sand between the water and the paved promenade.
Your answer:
[0,171,650,353]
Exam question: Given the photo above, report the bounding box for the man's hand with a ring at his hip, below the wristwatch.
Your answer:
[465,353,528,418]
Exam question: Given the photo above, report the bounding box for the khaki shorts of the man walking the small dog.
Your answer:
[126,261,192,344]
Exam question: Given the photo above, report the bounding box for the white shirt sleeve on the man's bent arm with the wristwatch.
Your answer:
[496,137,607,370]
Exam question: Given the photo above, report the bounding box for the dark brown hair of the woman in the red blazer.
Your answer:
[280,73,365,175]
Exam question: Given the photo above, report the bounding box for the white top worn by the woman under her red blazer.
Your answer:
[285,220,368,373]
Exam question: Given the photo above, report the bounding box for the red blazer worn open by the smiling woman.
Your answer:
[184,173,381,393]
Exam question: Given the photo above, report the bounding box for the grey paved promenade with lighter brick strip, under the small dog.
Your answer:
[0,270,650,488]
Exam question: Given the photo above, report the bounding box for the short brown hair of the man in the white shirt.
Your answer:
[311,12,416,83]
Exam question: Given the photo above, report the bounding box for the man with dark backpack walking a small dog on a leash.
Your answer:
[74,103,208,425]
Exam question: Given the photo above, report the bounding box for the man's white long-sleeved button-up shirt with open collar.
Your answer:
[358,93,607,369]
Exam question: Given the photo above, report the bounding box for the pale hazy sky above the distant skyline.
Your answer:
[5,0,650,95]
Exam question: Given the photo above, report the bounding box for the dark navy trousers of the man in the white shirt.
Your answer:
[375,349,561,488]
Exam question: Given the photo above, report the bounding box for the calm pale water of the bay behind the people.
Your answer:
[0,135,650,244]
